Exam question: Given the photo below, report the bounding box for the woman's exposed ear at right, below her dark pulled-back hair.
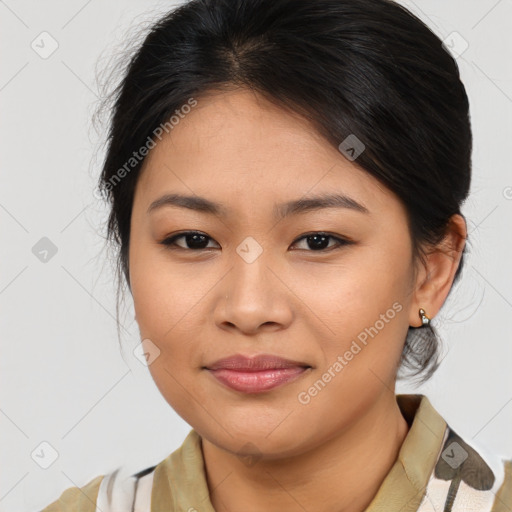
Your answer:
[409,214,467,327]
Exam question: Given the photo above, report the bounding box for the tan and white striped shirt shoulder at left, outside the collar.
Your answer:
[42,465,157,512]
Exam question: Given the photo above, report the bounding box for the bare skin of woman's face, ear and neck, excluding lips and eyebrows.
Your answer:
[129,89,466,512]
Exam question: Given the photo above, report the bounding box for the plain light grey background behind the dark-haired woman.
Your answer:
[0,0,512,512]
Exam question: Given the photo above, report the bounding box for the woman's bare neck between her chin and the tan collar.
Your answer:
[202,394,409,512]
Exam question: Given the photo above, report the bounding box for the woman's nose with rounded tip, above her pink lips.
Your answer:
[215,251,293,334]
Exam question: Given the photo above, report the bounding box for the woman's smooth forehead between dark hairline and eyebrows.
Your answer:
[136,89,399,216]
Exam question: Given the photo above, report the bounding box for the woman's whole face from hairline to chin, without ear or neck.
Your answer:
[129,89,420,458]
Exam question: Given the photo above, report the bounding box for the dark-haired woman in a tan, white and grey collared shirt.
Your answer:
[41,0,512,512]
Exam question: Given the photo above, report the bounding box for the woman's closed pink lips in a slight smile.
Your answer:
[206,354,311,393]
